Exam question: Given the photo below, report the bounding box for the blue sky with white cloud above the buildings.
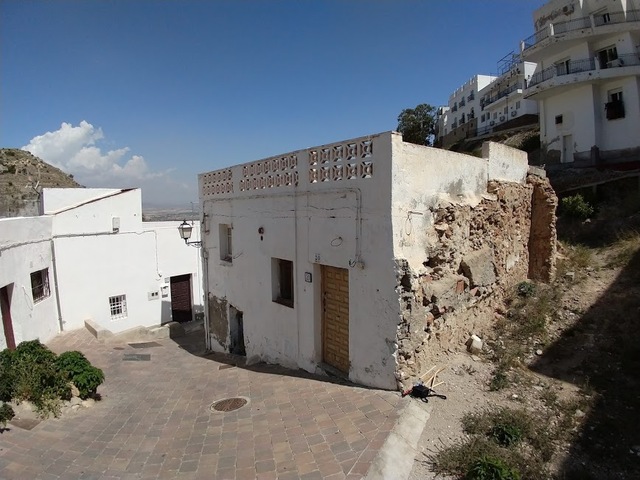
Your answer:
[0,0,544,205]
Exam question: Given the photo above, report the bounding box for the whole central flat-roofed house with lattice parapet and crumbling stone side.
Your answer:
[198,131,555,389]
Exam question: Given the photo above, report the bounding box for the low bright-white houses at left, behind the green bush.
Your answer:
[0,189,204,348]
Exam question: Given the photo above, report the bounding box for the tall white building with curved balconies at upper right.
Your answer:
[521,0,640,167]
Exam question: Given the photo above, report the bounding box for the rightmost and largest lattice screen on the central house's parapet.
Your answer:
[309,140,373,183]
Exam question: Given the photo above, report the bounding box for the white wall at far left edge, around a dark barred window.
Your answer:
[0,217,59,349]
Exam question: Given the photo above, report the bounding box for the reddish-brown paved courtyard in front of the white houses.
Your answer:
[0,329,400,480]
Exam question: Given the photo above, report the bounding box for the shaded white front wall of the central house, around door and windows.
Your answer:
[199,133,399,388]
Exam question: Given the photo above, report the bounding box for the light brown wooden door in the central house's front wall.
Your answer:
[322,265,349,373]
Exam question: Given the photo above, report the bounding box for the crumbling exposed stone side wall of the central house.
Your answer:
[396,175,557,389]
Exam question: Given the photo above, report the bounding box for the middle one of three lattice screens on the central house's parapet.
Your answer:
[240,154,298,192]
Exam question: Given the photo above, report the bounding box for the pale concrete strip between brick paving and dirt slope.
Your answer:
[365,397,432,480]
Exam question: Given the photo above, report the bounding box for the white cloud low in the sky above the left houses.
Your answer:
[22,120,195,204]
